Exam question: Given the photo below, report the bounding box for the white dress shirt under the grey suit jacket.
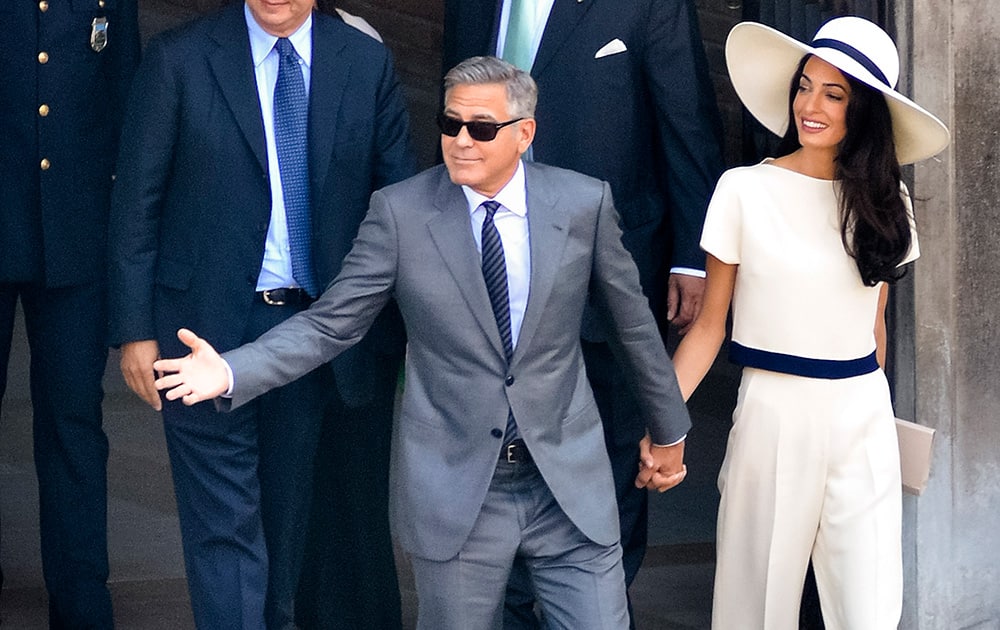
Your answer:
[462,162,531,348]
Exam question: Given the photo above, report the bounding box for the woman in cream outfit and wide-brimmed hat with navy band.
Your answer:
[674,17,948,630]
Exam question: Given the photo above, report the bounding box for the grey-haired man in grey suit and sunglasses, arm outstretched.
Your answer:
[155,57,690,630]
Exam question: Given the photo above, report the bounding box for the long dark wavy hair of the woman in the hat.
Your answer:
[777,55,912,286]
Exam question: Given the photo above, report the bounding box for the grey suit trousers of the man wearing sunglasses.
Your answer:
[410,460,628,630]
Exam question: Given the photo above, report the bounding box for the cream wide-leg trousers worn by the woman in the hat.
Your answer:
[712,368,902,630]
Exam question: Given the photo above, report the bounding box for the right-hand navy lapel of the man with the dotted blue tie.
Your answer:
[309,12,351,200]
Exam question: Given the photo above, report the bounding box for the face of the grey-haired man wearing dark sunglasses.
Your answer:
[441,83,535,198]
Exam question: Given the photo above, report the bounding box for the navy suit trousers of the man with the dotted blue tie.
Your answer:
[161,303,331,630]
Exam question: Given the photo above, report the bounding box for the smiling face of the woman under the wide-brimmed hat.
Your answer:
[792,56,851,153]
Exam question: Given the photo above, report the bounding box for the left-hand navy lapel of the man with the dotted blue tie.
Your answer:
[209,2,267,173]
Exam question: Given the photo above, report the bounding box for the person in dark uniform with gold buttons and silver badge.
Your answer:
[0,0,139,628]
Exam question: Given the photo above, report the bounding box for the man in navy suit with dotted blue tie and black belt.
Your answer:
[111,0,412,630]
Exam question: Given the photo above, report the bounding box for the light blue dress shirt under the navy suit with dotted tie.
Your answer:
[243,5,312,291]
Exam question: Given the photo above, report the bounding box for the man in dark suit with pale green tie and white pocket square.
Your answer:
[444,0,723,624]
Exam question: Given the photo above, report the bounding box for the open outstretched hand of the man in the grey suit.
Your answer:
[153,328,229,405]
